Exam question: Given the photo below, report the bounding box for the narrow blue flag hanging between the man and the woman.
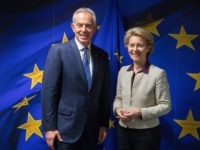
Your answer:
[94,0,130,150]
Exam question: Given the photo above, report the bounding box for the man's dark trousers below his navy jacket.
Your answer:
[55,128,97,150]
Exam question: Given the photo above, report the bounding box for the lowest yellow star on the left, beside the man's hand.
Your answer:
[18,113,43,141]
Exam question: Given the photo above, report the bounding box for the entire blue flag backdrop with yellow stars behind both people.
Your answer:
[0,0,200,150]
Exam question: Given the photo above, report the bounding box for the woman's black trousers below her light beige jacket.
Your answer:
[118,125,160,150]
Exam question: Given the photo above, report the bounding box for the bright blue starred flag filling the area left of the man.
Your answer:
[0,0,112,150]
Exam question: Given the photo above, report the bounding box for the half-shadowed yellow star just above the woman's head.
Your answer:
[136,13,163,36]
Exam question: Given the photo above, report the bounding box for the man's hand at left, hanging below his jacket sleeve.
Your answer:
[45,130,62,150]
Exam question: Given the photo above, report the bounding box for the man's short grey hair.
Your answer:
[72,7,96,24]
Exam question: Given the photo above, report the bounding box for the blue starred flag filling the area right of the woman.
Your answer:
[119,0,200,150]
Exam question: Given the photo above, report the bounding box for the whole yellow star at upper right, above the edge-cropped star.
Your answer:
[169,26,198,50]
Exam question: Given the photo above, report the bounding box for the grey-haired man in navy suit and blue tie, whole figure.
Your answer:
[42,8,110,150]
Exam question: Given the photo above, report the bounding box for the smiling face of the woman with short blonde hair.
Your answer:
[127,35,151,63]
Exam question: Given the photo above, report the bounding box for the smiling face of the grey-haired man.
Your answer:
[71,12,96,46]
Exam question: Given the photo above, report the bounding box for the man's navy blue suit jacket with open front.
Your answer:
[42,39,110,143]
